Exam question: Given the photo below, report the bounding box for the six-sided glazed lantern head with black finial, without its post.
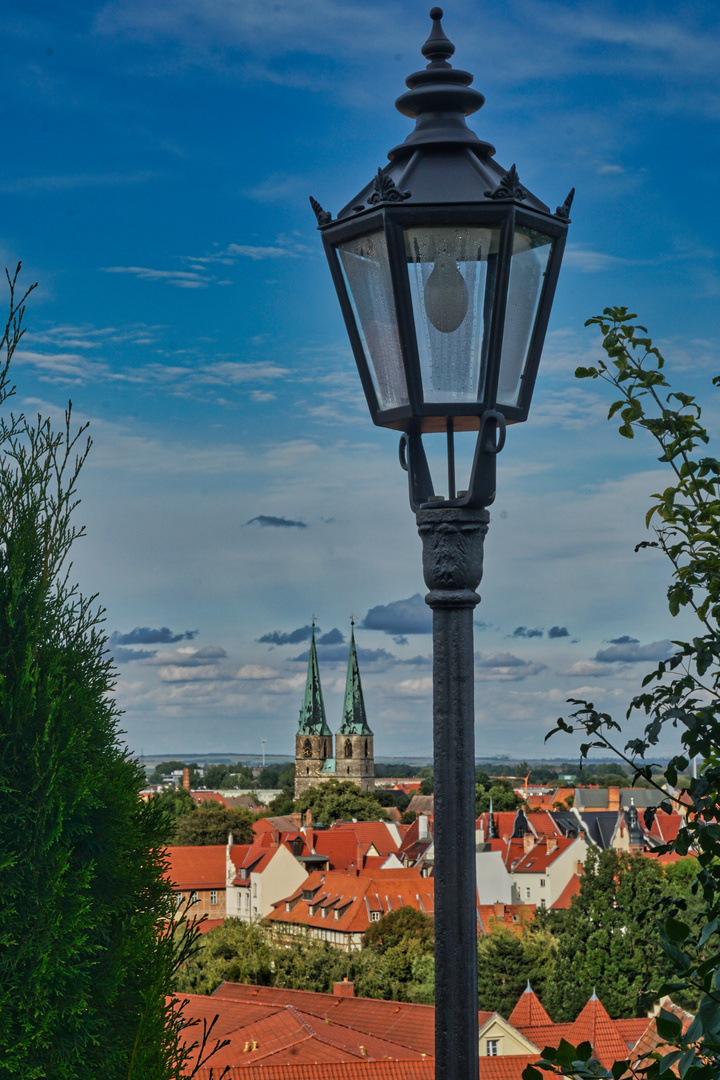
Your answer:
[311,8,574,504]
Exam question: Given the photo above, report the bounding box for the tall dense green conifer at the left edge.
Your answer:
[0,266,191,1080]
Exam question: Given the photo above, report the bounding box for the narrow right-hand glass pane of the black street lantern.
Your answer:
[497,226,553,405]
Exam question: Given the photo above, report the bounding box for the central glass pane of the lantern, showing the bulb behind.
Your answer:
[405,225,500,404]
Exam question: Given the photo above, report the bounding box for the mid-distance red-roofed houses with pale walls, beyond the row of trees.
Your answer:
[168,788,682,949]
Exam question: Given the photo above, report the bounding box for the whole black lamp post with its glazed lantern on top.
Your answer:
[311,8,573,1080]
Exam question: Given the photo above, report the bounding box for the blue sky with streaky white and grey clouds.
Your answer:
[5,0,720,756]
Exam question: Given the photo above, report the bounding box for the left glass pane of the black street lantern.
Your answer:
[338,229,408,409]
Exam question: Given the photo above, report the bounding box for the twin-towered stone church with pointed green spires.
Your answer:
[295,626,375,799]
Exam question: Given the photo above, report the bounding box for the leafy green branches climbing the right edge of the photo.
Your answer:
[524,308,720,1080]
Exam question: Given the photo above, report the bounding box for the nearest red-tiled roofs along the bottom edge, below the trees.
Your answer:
[175,982,692,1080]
